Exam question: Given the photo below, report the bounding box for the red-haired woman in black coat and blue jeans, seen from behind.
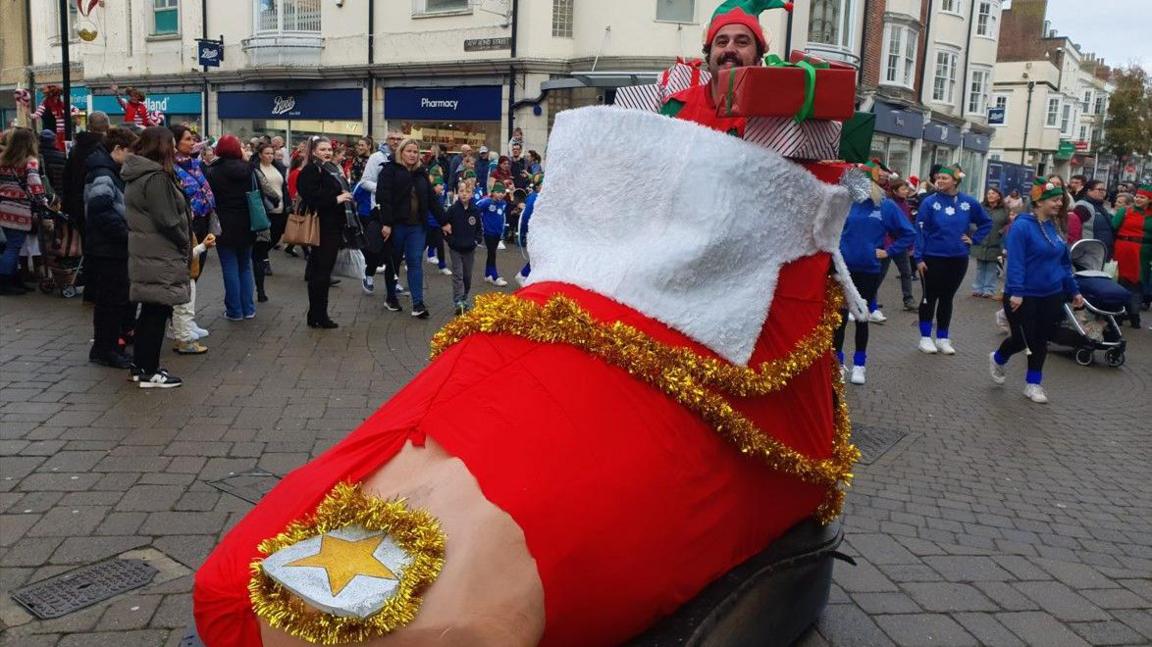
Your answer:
[207,135,256,321]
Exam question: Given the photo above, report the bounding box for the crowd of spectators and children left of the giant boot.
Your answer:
[0,112,543,388]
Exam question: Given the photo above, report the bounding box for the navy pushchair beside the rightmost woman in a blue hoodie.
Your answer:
[1051,238,1129,367]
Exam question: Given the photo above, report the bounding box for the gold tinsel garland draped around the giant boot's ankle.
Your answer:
[432,279,859,523]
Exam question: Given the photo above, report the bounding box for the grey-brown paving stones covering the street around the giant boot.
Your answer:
[0,248,1152,647]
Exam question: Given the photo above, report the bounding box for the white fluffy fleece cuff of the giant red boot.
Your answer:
[529,106,849,366]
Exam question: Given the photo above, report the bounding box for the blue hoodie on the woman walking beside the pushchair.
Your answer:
[1005,213,1079,297]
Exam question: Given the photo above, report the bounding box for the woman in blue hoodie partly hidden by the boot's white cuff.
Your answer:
[835,184,916,385]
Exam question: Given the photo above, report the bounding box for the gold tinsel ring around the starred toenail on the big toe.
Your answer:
[248,484,446,645]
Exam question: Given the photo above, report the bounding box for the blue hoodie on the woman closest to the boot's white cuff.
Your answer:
[840,198,916,274]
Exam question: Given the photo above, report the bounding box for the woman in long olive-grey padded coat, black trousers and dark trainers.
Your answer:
[121,127,192,389]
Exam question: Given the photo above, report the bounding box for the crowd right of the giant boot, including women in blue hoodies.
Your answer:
[835,160,1152,403]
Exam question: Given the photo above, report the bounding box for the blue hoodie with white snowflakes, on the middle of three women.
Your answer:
[916,192,992,262]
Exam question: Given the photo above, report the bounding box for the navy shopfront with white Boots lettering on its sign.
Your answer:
[217,87,364,149]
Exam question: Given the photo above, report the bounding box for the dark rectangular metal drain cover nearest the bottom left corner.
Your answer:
[12,560,159,619]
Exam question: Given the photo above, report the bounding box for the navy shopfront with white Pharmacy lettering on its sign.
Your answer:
[384,85,503,151]
